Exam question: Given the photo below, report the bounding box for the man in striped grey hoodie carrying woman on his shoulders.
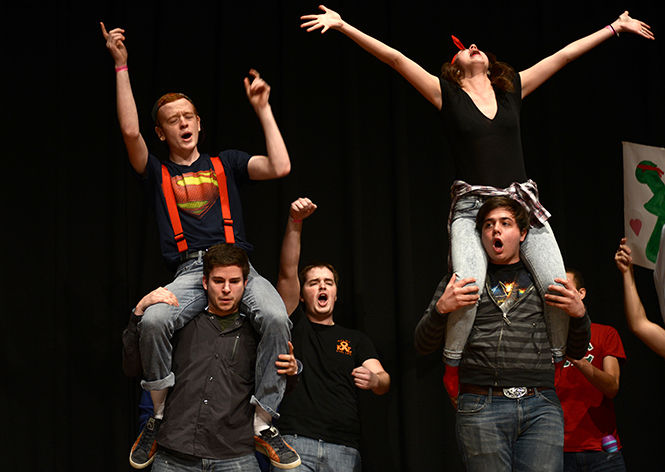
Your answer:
[415,197,590,472]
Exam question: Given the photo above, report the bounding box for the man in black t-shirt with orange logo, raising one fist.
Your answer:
[277,198,390,472]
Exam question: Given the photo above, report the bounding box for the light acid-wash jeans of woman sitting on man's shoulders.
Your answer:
[444,195,569,365]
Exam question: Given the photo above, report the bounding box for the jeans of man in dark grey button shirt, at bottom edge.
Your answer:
[152,449,261,472]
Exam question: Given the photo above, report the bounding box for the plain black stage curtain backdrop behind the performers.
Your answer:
[6,0,665,471]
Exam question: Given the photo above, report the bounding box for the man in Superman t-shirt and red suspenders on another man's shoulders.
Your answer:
[101,23,300,469]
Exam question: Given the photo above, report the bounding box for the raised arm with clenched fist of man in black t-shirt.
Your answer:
[277,198,316,315]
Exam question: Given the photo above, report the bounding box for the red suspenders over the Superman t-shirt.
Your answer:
[162,157,235,252]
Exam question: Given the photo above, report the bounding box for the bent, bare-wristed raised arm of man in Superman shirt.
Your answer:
[244,69,291,180]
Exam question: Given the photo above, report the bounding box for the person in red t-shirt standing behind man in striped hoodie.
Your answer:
[556,269,626,472]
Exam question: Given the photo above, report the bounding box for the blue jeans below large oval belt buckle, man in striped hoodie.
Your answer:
[457,390,563,472]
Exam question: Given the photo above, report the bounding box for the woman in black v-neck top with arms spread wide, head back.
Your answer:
[301,5,654,365]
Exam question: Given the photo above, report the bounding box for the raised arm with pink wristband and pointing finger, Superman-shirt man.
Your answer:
[99,22,148,174]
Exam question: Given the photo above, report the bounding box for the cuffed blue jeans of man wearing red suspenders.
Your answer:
[138,256,291,418]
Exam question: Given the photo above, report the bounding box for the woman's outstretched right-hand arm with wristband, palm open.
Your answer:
[520,11,654,98]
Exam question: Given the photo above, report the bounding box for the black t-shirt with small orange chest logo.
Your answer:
[277,307,377,449]
